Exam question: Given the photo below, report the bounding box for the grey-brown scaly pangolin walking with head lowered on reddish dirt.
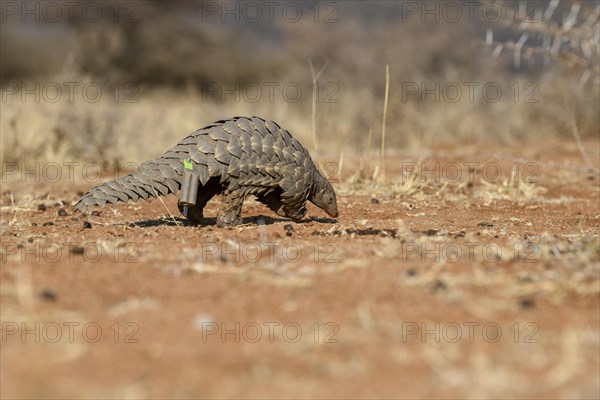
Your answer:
[75,117,338,227]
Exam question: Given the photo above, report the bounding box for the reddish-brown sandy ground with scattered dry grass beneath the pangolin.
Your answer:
[1,142,600,398]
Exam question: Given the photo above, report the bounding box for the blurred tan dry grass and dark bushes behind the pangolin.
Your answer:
[0,1,600,166]
